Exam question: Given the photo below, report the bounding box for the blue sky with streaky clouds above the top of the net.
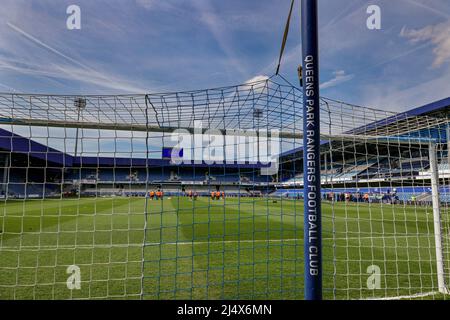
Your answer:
[0,0,450,111]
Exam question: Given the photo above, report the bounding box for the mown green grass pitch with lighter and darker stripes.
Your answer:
[0,197,450,299]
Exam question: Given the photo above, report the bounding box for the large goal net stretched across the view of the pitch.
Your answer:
[0,77,450,299]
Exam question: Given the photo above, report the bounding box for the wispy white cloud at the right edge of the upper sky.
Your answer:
[400,22,450,68]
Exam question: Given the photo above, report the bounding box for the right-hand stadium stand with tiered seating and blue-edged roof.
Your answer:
[275,98,450,202]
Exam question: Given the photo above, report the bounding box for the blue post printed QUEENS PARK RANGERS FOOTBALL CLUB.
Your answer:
[301,0,322,300]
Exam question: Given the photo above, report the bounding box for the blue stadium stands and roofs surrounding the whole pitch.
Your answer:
[0,98,450,202]
